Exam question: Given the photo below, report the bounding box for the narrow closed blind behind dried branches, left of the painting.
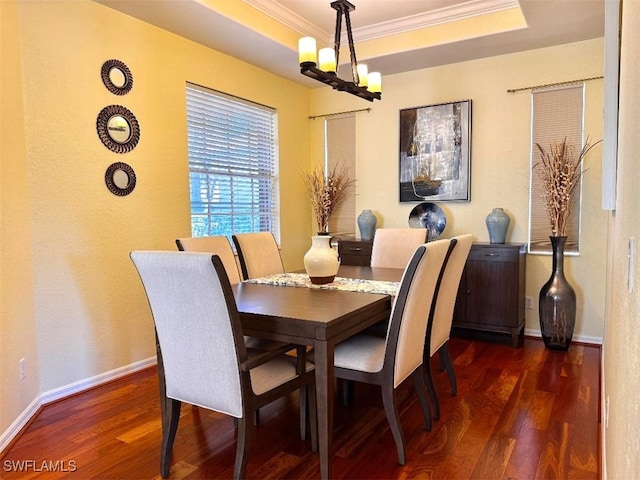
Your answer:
[325,114,356,236]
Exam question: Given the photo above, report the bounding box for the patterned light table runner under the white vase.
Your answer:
[245,273,400,297]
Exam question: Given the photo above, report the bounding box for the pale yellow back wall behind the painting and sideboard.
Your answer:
[311,39,607,342]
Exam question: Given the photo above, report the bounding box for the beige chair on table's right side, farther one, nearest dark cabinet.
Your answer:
[424,233,473,419]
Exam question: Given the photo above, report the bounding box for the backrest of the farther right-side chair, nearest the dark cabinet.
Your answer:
[427,233,473,356]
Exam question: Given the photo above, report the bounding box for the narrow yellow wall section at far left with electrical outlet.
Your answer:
[0,2,40,442]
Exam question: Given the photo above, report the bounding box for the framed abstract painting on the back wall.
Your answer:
[399,100,471,202]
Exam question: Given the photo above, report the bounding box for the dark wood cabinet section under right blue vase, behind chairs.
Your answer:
[453,243,526,347]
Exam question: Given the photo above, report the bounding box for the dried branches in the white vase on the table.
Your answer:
[302,165,356,235]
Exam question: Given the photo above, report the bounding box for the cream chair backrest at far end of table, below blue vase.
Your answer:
[371,228,429,268]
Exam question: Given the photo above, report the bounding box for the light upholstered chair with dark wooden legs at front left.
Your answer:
[131,251,317,478]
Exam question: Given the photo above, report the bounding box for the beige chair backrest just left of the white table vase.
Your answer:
[232,232,284,280]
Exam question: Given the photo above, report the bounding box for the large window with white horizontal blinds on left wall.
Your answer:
[182,84,280,239]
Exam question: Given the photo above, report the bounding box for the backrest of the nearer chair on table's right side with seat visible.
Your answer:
[383,239,450,388]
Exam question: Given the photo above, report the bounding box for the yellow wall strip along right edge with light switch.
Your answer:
[602,2,640,480]
